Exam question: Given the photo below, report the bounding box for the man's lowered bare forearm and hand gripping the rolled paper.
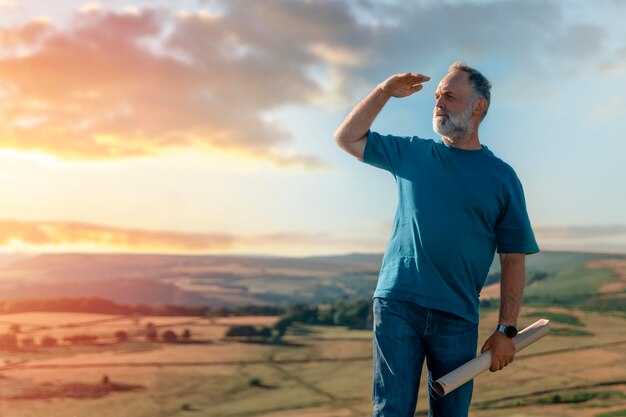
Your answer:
[480,253,526,372]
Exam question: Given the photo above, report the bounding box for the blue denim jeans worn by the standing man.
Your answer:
[372,298,478,417]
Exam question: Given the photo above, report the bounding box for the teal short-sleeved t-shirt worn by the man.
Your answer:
[363,131,539,323]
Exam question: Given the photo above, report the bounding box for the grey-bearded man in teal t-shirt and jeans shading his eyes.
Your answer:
[334,62,539,417]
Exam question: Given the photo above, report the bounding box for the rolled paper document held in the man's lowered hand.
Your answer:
[434,319,550,395]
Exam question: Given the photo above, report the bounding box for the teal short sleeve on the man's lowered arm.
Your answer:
[496,175,539,255]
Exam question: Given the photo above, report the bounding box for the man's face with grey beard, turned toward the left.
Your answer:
[433,71,473,140]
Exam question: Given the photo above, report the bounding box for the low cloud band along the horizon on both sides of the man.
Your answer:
[0,220,626,256]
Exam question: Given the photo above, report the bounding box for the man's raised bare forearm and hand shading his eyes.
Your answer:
[333,73,430,160]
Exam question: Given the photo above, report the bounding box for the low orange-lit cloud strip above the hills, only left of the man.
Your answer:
[0,220,384,255]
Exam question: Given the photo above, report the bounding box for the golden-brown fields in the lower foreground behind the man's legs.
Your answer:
[0,308,626,417]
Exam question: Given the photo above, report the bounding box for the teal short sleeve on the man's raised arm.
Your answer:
[362,130,410,176]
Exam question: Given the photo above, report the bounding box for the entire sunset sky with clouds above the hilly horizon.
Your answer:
[0,0,626,256]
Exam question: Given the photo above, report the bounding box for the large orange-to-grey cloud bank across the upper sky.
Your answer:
[0,0,606,168]
